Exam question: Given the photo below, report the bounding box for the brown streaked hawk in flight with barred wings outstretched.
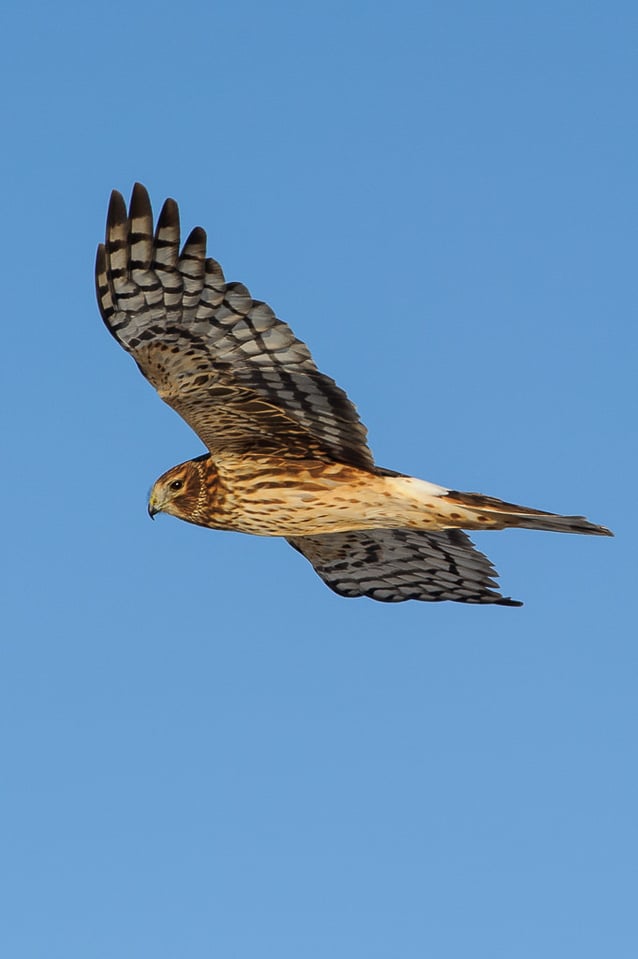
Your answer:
[96,183,612,606]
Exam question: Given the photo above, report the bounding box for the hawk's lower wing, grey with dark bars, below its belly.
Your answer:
[288,529,522,606]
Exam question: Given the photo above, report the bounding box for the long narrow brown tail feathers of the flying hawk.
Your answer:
[442,490,614,536]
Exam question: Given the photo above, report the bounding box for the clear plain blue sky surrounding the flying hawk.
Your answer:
[0,0,638,959]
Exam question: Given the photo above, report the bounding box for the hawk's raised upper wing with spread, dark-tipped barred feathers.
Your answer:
[95,183,374,469]
